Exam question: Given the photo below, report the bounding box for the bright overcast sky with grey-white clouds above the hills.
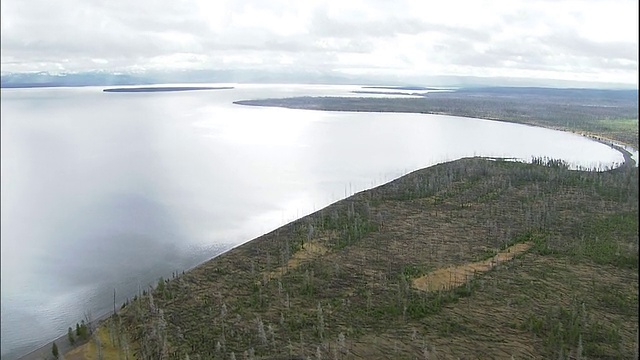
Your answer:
[0,0,638,84]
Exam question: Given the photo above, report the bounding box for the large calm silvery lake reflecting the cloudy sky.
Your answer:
[1,84,623,359]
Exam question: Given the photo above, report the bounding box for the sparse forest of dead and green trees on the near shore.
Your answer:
[84,154,638,359]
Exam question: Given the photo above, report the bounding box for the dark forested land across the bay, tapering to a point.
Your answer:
[234,89,638,151]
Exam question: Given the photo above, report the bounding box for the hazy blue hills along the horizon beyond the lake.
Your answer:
[0,69,637,90]
